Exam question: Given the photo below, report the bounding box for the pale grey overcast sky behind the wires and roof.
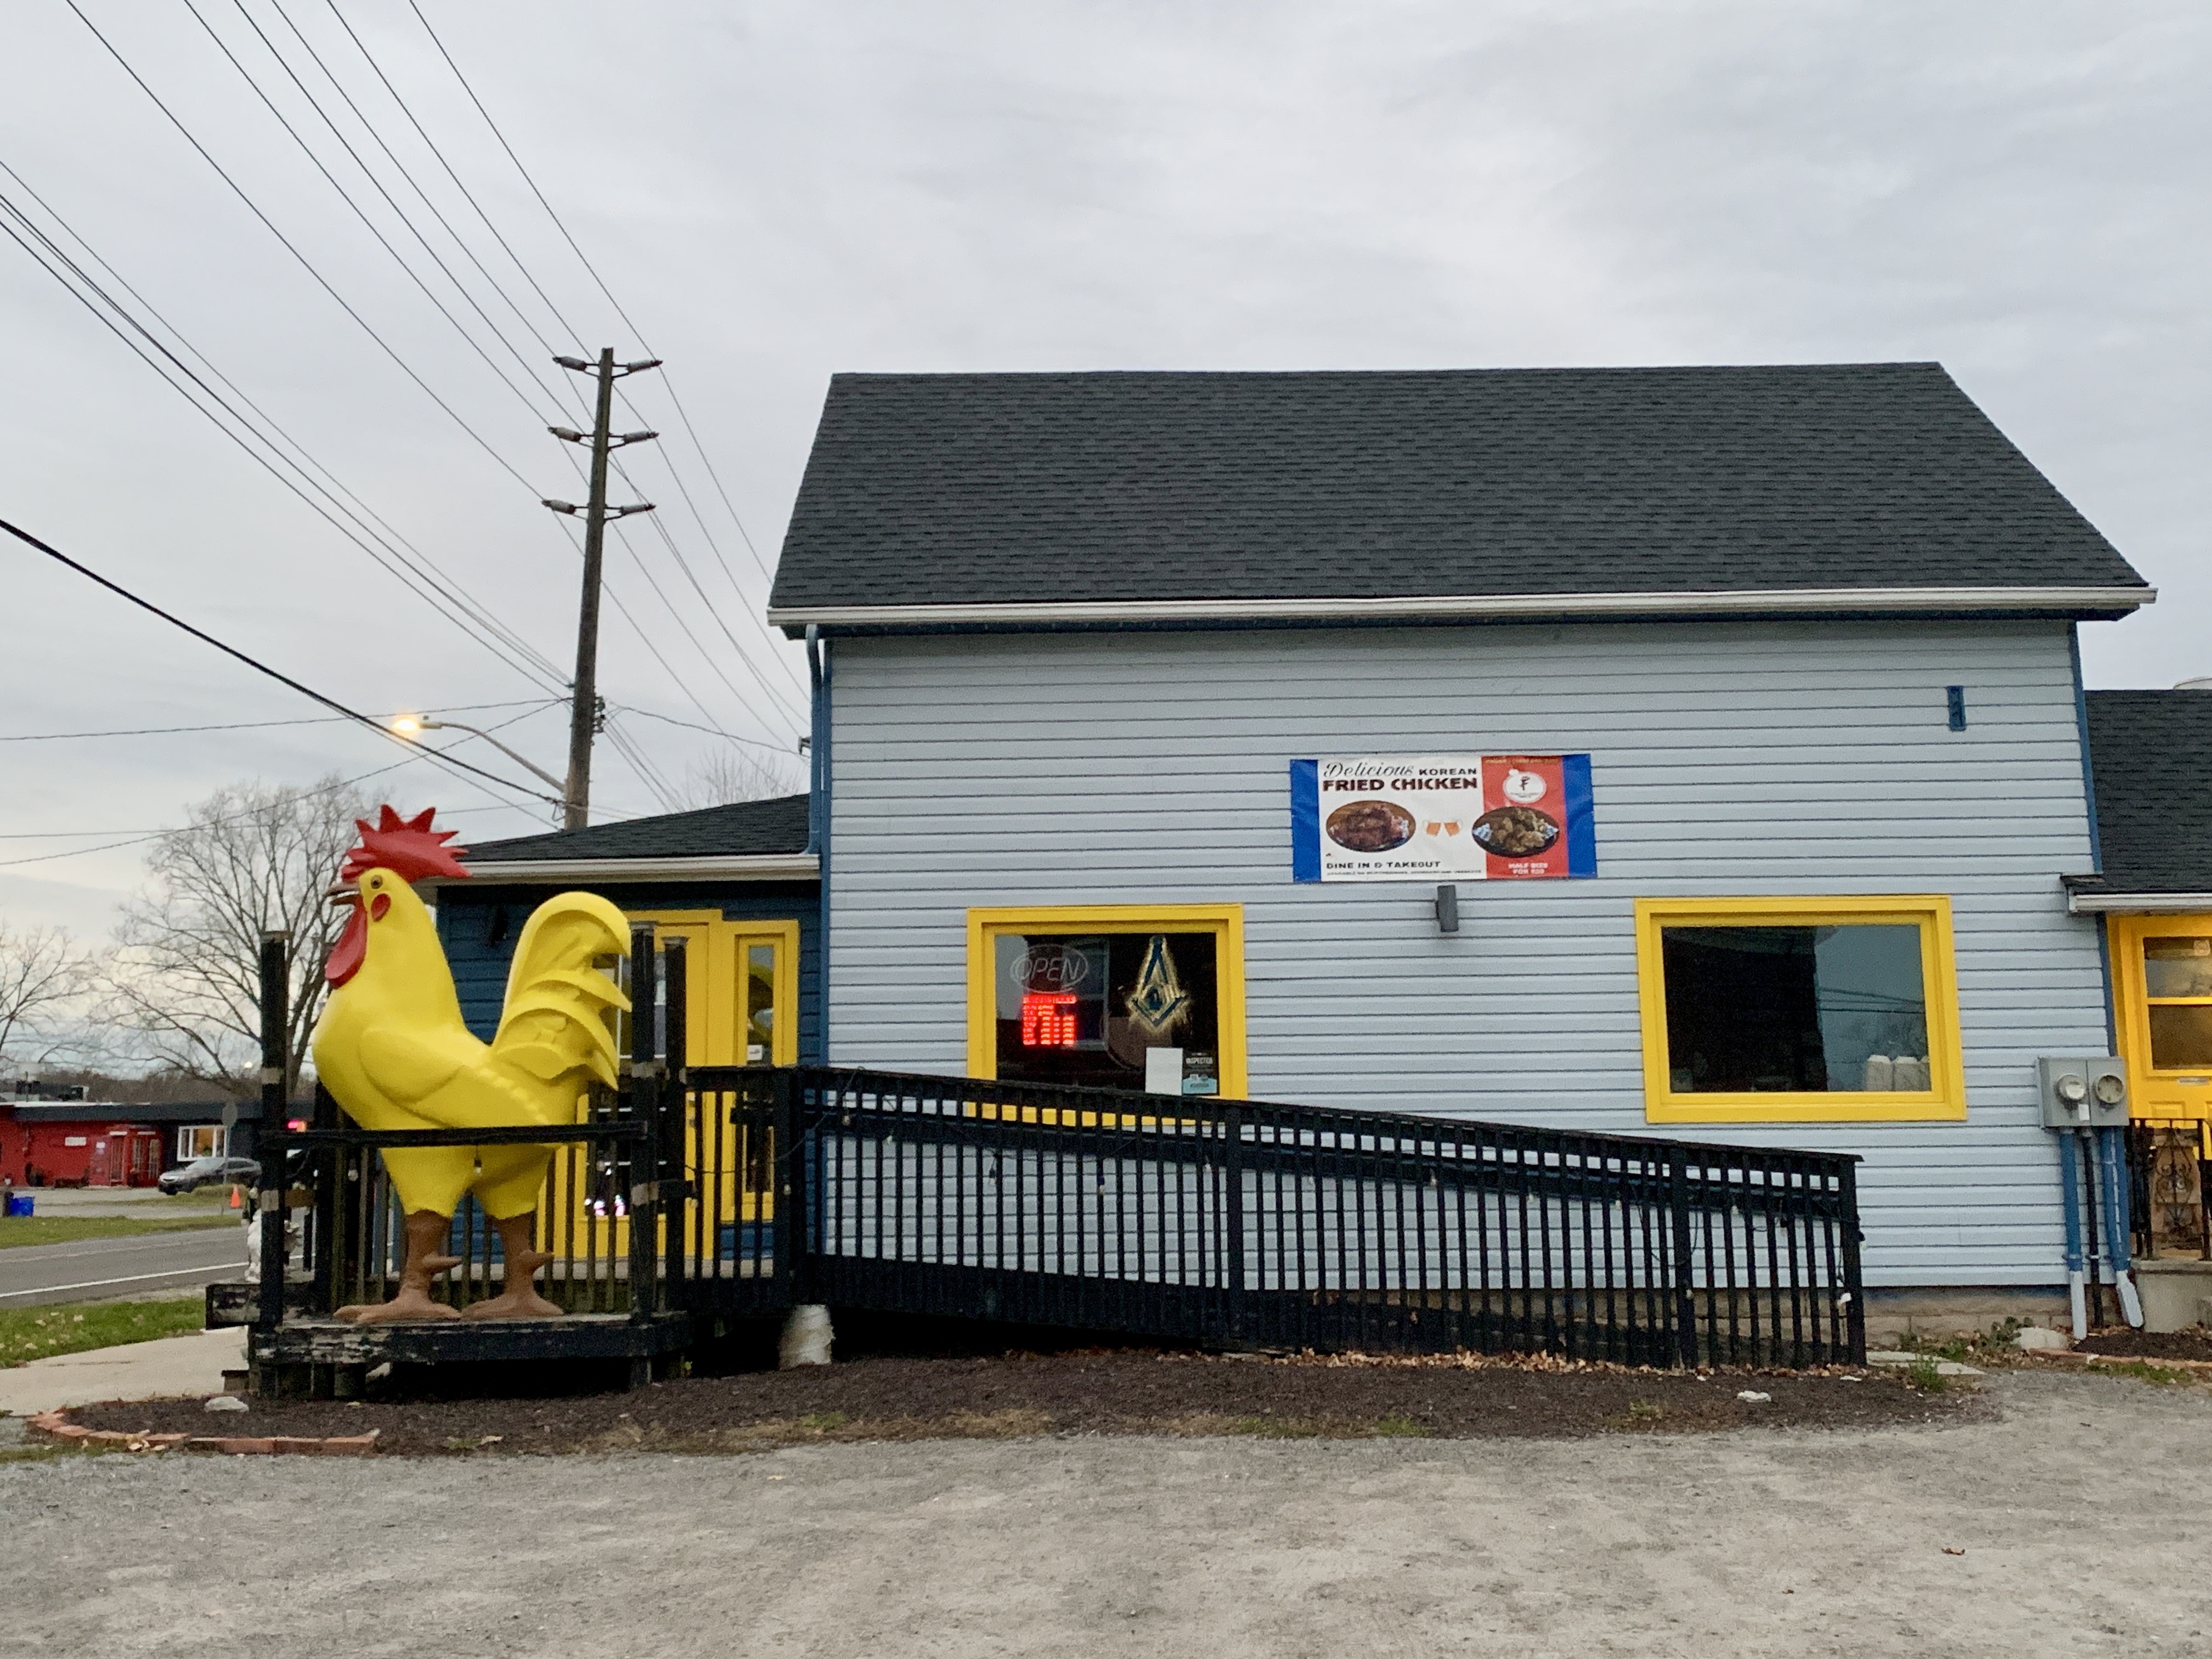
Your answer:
[0,0,2212,938]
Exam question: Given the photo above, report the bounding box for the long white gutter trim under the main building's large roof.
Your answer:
[768,589,2159,628]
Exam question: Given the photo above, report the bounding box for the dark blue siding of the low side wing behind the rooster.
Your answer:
[438,881,823,1062]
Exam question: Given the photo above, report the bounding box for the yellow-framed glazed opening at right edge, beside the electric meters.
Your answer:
[2108,916,2212,1121]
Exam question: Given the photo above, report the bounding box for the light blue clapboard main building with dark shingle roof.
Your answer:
[770,363,2152,1312]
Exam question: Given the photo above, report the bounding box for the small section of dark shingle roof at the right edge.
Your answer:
[2088,690,2212,894]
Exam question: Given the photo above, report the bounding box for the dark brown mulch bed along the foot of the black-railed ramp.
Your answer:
[69,1350,1987,1455]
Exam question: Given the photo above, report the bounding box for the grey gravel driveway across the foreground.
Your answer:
[0,1376,2212,1659]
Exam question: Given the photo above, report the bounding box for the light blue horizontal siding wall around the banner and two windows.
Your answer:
[830,622,2106,1285]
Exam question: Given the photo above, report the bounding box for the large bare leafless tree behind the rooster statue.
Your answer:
[106,776,367,1095]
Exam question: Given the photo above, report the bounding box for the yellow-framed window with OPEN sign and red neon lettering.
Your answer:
[969,905,1245,1097]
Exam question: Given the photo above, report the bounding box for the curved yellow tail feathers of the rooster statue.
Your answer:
[491,894,630,1106]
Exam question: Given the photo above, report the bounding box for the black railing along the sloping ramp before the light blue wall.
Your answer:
[662,1066,1865,1365]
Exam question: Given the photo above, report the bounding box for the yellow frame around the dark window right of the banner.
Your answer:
[1637,894,1966,1124]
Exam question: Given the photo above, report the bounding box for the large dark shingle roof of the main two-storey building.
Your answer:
[770,363,2141,613]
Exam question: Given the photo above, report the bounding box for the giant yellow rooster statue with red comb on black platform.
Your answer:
[312,808,630,1325]
